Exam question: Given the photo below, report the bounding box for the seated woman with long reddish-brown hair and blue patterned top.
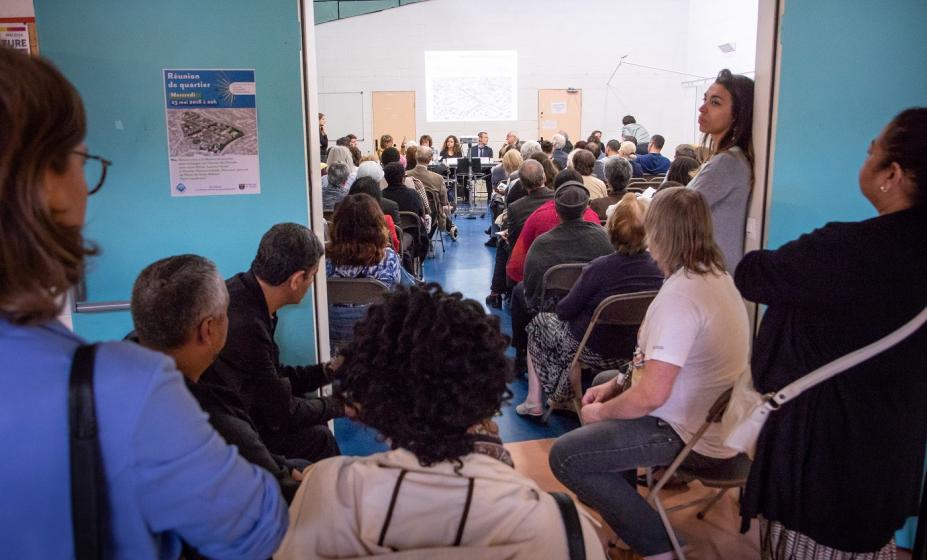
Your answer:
[325,194,401,350]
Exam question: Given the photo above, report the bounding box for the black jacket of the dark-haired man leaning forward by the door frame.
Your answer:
[202,271,344,439]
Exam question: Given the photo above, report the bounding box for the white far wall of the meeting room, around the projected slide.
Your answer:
[315,0,756,158]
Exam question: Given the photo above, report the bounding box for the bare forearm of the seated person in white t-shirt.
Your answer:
[581,360,682,424]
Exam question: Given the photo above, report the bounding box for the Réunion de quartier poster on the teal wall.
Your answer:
[164,70,261,197]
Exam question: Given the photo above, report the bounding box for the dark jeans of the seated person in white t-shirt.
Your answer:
[549,416,725,556]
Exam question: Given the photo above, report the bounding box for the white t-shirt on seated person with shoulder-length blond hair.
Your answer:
[638,269,750,459]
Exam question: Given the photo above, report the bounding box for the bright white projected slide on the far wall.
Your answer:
[425,51,518,122]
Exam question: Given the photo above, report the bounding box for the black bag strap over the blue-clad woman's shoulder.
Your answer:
[68,344,106,560]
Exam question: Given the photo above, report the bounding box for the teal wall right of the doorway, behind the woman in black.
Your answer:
[768,0,927,547]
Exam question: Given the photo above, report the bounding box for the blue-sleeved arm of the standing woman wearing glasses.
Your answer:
[127,359,288,559]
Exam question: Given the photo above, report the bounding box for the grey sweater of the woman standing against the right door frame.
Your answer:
[689,147,752,274]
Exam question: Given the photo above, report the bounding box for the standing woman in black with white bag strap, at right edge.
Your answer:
[735,108,927,560]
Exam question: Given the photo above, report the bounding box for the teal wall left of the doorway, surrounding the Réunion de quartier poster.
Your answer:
[35,0,315,362]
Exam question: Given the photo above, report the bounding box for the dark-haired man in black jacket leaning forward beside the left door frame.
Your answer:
[203,223,344,461]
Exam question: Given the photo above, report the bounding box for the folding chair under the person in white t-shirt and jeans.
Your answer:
[646,389,752,560]
